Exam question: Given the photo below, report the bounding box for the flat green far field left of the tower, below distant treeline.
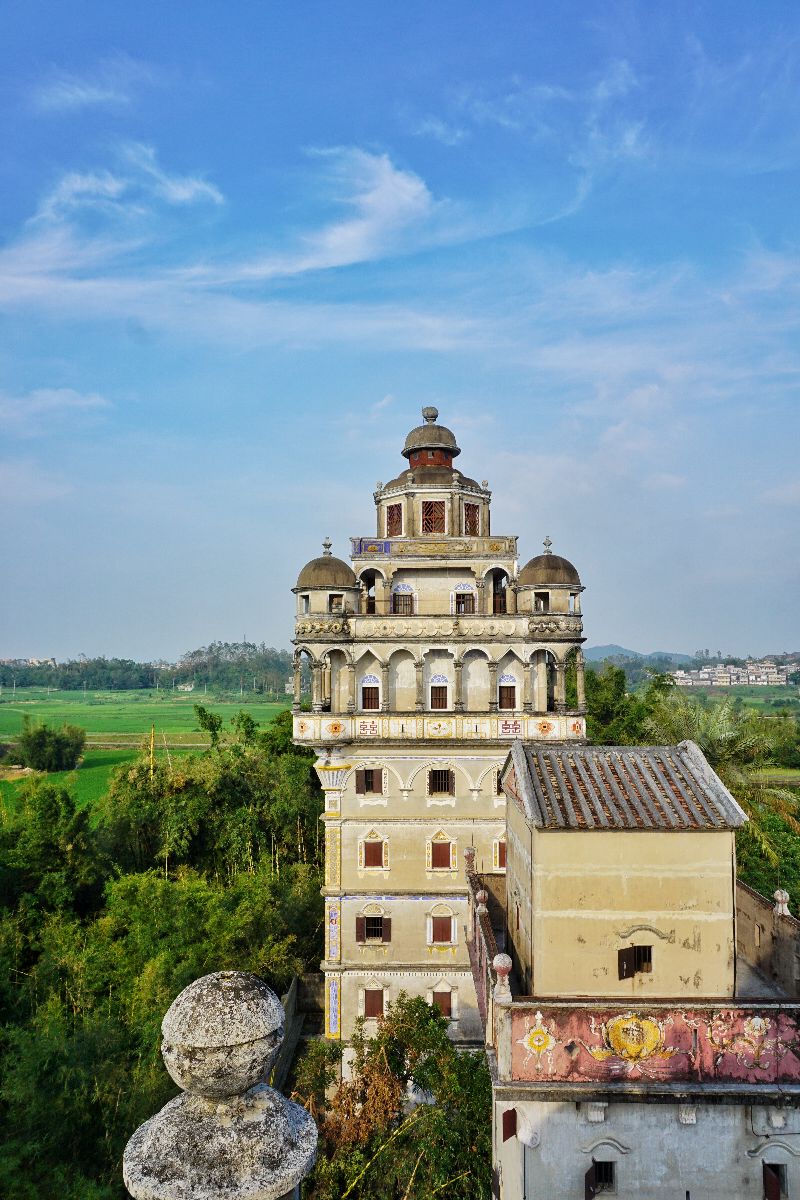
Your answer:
[0,688,291,746]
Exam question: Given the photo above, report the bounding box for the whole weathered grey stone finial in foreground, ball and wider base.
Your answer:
[122,971,317,1200]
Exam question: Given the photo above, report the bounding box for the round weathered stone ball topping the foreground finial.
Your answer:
[161,971,284,1099]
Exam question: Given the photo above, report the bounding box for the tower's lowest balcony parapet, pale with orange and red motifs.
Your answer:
[293,710,587,746]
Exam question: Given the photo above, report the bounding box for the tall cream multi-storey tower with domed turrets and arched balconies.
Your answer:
[293,408,585,1043]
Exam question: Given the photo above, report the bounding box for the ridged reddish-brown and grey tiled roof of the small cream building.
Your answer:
[503,742,747,830]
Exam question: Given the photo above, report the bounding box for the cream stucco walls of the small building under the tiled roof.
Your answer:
[507,803,735,998]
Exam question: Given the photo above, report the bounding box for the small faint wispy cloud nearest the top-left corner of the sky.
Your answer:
[30,54,158,113]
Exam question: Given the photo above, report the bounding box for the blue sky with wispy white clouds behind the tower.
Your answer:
[0,0,800,659]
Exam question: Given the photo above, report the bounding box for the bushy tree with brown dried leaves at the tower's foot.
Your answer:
[296,994,492,1200]
